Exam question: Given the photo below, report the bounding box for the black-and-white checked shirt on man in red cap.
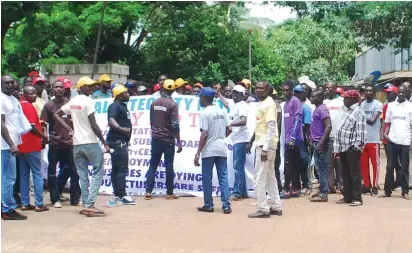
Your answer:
[333,104,366,153]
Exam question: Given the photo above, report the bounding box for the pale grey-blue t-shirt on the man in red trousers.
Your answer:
[361,99,383,143]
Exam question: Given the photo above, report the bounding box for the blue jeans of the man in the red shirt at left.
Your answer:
[18,152,43,207]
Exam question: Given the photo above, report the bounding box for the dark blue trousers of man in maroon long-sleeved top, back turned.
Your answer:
[146,138,175,195]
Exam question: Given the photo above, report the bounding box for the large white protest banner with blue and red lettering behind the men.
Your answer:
[95,95,257,196]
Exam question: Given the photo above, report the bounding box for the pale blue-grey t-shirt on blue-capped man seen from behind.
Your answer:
[200,105,229,158]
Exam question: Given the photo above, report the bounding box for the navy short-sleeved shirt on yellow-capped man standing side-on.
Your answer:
[107,101,132,142]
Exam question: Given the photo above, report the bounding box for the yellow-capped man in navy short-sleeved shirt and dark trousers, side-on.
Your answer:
[107,84,136,205]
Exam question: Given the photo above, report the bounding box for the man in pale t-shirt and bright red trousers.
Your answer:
[361,84,383,196]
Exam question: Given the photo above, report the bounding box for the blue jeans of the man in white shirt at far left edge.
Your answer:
[1,150,17,213]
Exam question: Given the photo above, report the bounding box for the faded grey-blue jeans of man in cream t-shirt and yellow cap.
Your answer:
[73,143,103,208]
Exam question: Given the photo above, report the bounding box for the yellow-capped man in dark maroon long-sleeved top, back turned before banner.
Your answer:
[144,79,182,200]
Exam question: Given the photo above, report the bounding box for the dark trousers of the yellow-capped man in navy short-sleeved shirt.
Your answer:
[107,141,129,198]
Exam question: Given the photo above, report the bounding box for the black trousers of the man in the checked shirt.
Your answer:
[340,147,362,202]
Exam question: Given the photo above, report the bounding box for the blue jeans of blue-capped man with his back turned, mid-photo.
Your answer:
[202,156,230,209]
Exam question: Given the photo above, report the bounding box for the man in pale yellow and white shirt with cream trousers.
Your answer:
[248,81,282,218]
